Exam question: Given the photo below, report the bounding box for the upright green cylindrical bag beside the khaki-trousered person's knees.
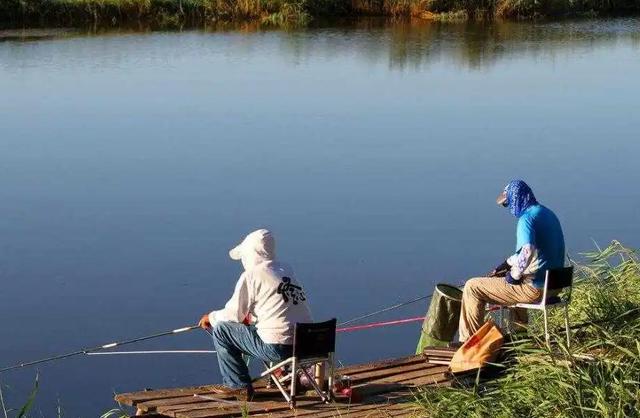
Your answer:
[416,283,462,354]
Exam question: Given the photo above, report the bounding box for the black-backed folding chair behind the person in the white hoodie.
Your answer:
[260,318,336,409]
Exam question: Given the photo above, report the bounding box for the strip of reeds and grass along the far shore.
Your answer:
[0,0,640,26]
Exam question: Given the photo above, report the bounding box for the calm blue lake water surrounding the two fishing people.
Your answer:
[0,15,640,417]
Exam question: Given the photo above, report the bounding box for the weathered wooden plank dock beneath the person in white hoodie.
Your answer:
[115,348,454,418]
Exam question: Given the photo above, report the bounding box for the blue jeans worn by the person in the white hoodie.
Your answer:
[212,321,293,389]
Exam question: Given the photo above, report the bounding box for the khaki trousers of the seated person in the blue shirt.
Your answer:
[459,277,542,341]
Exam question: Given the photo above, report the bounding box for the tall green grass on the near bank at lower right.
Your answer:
[418,243,640,418]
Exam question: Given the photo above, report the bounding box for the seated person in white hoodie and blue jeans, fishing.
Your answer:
[199,229,312,400]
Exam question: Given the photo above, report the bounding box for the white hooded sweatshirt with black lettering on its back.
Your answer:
[209,229,312,344]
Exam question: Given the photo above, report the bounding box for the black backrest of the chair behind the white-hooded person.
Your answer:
[293,318,337,359]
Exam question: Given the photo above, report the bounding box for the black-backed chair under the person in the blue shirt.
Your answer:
[499,267,573,347]
